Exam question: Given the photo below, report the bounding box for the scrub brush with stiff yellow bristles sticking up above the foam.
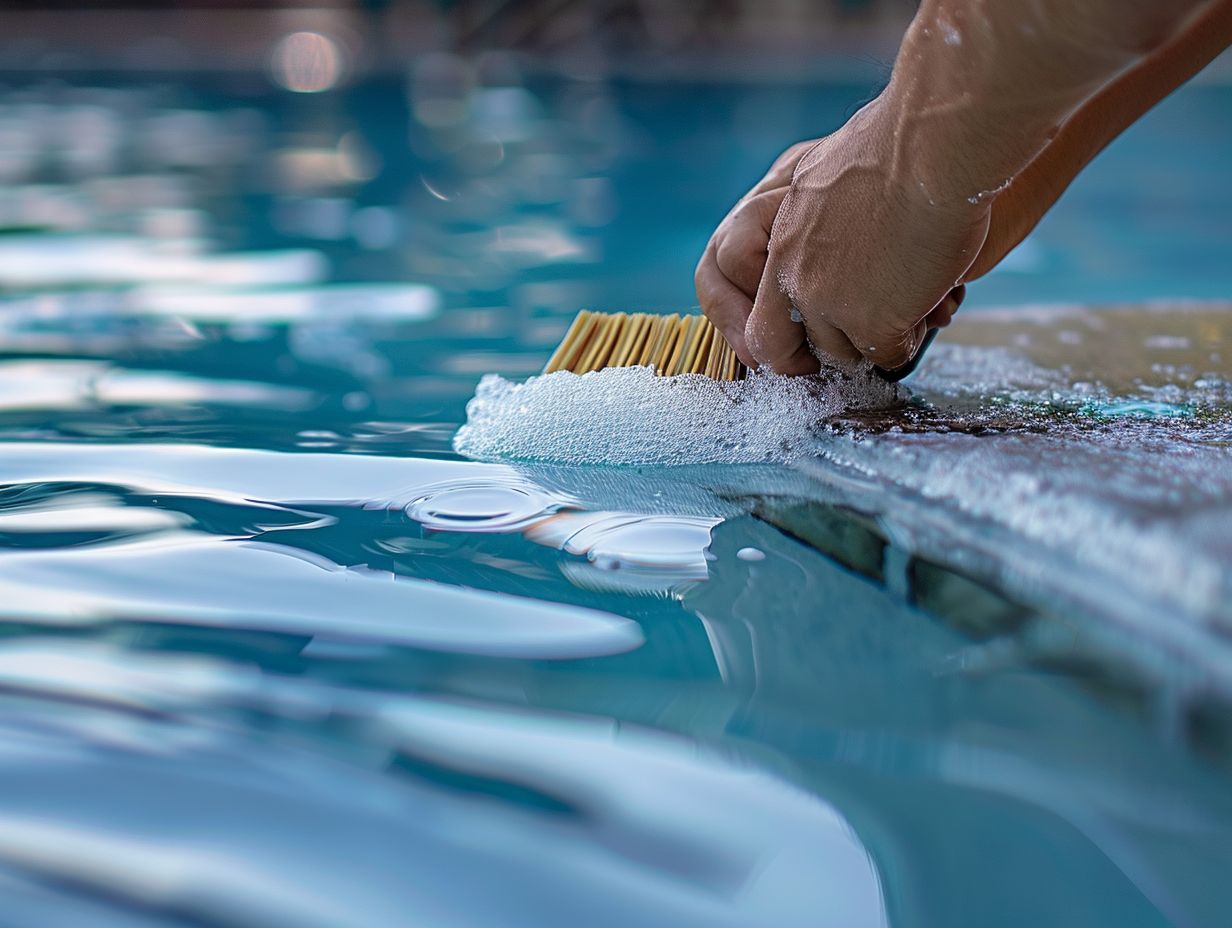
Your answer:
[543,309,938,383]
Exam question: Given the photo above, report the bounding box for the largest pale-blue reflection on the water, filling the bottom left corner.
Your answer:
[0,642,885,926]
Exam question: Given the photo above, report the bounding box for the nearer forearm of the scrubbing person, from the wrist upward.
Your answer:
[881,0,1209,200]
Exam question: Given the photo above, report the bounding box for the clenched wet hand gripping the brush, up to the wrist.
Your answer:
[695,101,991,373]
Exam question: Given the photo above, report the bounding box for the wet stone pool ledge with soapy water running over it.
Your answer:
[818,311,1232,704]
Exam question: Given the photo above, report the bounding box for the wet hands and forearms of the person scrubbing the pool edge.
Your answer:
[695,0,1232,373]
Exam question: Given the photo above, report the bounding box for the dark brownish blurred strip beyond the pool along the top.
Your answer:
[4,0,915,79]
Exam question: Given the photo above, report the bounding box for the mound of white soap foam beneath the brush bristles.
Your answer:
[453,364,898,465]
